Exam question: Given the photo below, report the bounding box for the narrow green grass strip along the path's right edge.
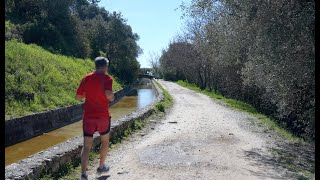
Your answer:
[176,80,303,142]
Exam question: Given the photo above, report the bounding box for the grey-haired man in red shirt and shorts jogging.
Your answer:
[76,57,114,179]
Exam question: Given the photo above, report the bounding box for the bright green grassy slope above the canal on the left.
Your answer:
[5,41,121,119]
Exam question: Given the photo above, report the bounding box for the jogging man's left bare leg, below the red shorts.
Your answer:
[81,136,93,174]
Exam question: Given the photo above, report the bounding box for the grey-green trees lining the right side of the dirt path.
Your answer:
[160,0,315,138]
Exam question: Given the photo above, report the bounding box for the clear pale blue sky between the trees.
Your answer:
[99,0,190,67]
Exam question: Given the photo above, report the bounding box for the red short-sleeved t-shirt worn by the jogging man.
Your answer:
[77,72,112,120]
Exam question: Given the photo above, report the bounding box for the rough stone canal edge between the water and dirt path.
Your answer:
[5,80,164,179]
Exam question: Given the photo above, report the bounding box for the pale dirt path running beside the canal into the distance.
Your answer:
[88,81,312,180]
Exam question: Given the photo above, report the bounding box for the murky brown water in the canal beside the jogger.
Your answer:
[5,81,156,166]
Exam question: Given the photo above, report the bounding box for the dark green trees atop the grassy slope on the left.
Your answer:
[5,0,142,83]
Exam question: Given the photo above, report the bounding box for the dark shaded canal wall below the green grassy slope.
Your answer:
[5,83,136,147]
